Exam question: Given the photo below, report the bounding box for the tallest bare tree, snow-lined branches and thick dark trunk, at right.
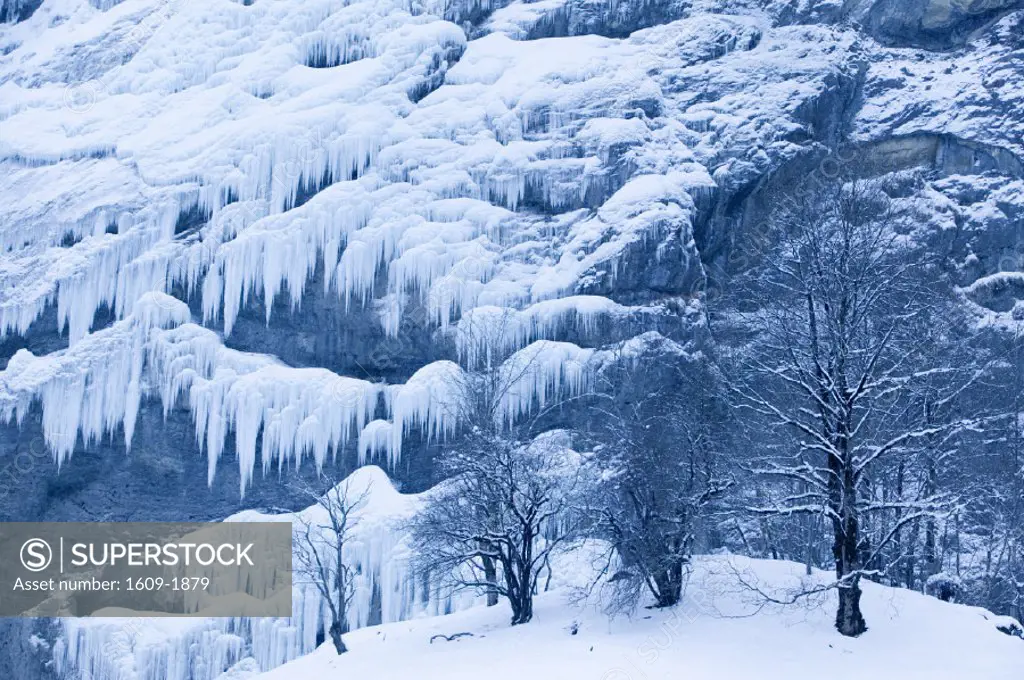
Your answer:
[733,175,965,636]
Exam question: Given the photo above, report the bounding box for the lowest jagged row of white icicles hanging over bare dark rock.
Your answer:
[0,293,595,494]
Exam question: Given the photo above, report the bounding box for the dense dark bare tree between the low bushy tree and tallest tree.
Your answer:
[592,338,732,610]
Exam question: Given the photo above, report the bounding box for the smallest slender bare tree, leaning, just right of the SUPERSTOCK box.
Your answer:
[295,479,370,654]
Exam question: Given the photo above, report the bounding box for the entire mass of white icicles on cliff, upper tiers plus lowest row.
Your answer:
[0,0,710,503]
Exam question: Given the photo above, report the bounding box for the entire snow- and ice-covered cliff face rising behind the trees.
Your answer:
[0,0,1024,561]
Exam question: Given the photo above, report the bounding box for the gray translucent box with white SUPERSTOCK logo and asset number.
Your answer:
[0,522,292,617]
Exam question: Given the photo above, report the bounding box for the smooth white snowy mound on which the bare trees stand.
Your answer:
[249,556,1024,680]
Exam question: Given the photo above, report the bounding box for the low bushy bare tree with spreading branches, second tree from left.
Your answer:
[410,433,584,626]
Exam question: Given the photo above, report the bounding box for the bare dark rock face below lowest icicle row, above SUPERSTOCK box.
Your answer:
[0,407,444,521]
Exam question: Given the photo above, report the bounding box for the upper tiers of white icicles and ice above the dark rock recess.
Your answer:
[0,0,710,352]
